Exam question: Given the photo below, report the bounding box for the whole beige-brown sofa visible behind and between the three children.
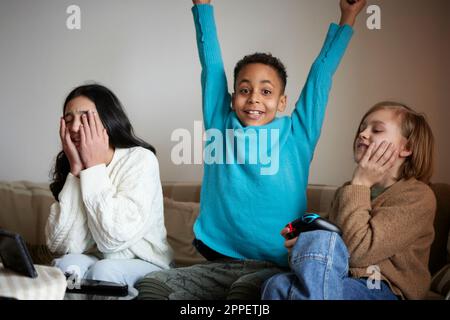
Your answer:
[0,181,450,299]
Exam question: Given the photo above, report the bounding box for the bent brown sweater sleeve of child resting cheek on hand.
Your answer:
[331,185,436,268]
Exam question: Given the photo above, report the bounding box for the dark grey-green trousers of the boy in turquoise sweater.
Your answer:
[135,259,286,300]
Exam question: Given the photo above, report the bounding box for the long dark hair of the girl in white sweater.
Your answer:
[50,84,156,201]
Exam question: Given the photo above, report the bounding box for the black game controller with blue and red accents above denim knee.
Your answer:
[285,213,342,239]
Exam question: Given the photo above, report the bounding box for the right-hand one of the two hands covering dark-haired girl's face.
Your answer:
[80,111,109,168]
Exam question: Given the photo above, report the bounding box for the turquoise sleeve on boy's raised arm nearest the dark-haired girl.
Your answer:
[192,4,231,129]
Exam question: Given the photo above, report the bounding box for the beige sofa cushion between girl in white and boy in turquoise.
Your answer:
[164,197,205,267]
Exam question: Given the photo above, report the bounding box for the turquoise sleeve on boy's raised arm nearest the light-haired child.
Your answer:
[292,23,353,157]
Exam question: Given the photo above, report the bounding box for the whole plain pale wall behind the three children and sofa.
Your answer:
[0,0,450,184]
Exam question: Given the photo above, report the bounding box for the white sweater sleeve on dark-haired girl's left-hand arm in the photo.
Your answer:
[45,173,94,254]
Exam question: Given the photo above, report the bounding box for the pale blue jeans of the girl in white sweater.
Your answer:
[53,254,161,288]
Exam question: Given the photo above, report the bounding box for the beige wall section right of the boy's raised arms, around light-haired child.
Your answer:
[310,0,450,183]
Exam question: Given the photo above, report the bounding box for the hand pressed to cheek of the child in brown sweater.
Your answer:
[352,141,398,188]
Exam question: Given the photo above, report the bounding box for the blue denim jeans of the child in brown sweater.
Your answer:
[262,230,398,300]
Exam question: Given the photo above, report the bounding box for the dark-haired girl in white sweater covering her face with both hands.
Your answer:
[46,84,172,287]
